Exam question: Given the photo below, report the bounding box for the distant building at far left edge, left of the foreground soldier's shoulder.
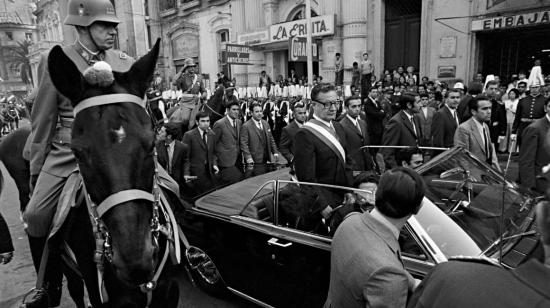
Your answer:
[0,1,36,95]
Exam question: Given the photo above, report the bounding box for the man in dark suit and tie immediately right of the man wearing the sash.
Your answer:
[340,96,373,171]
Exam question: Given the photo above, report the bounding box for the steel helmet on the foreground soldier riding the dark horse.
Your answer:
[65,0,121,27]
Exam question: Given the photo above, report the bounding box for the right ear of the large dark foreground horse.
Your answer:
[122,38,160,96]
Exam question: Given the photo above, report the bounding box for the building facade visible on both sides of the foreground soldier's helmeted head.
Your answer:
[28,0,150,85]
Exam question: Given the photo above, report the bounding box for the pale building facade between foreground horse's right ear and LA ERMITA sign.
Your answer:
[147,0,233,89]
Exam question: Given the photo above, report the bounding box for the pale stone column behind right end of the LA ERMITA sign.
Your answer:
[319,0,340,82]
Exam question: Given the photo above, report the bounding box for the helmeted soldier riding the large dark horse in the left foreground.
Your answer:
[23,0,134,307]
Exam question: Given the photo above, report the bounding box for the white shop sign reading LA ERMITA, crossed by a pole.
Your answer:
[269,15,334,42]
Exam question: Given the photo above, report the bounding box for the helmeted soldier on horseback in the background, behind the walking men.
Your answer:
[170,58,206,132]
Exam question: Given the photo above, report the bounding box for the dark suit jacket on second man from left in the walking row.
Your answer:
[183,127,216,178]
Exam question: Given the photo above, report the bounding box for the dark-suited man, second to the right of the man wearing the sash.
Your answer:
[380,93,422,170]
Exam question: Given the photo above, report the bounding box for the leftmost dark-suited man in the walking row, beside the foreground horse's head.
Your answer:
[155,122,189,193]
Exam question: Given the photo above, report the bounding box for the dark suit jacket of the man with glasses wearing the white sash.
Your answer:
[294,121,351,186]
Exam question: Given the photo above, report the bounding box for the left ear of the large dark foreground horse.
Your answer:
[48,45,82,105]
